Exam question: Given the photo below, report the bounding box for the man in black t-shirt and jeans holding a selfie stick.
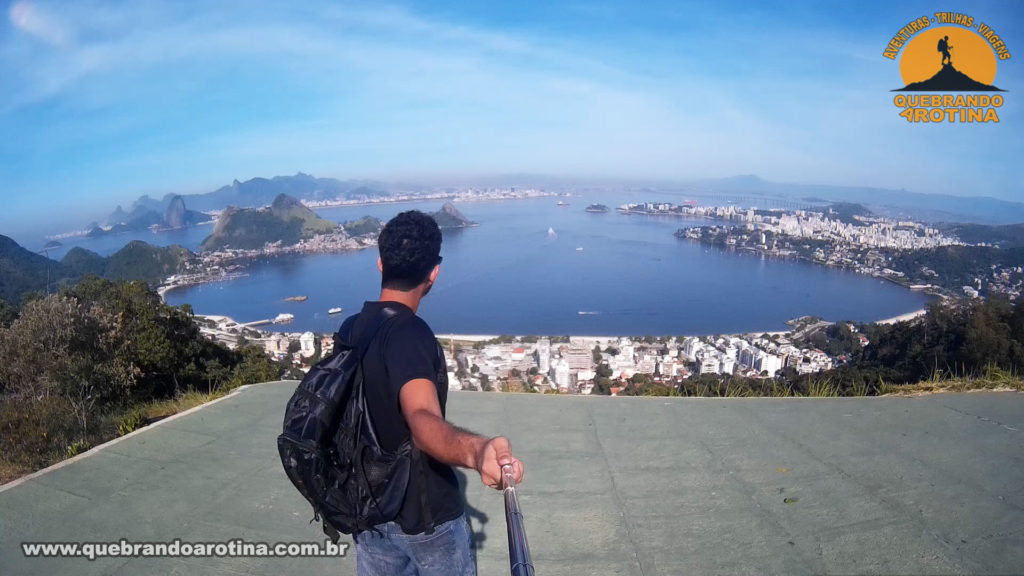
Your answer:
[341,210,523,576]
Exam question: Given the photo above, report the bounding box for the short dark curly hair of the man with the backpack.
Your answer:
[377,210,441,292]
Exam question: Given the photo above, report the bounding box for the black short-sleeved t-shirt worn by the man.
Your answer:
[339,302,463,534]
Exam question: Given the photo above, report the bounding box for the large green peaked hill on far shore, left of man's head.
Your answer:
[201,194,337,250]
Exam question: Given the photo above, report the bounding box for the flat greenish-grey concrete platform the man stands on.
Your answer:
[0,382,1024,576]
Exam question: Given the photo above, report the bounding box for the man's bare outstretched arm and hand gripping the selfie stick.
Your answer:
[398,378,523,489]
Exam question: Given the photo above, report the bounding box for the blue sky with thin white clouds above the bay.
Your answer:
[0,0,1024,234]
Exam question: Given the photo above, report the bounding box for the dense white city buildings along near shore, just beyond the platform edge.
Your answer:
[196,315,847,395]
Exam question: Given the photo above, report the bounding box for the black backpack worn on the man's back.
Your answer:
[278,307,433,542]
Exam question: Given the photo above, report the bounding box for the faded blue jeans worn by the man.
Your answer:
[355,515,476,576]
